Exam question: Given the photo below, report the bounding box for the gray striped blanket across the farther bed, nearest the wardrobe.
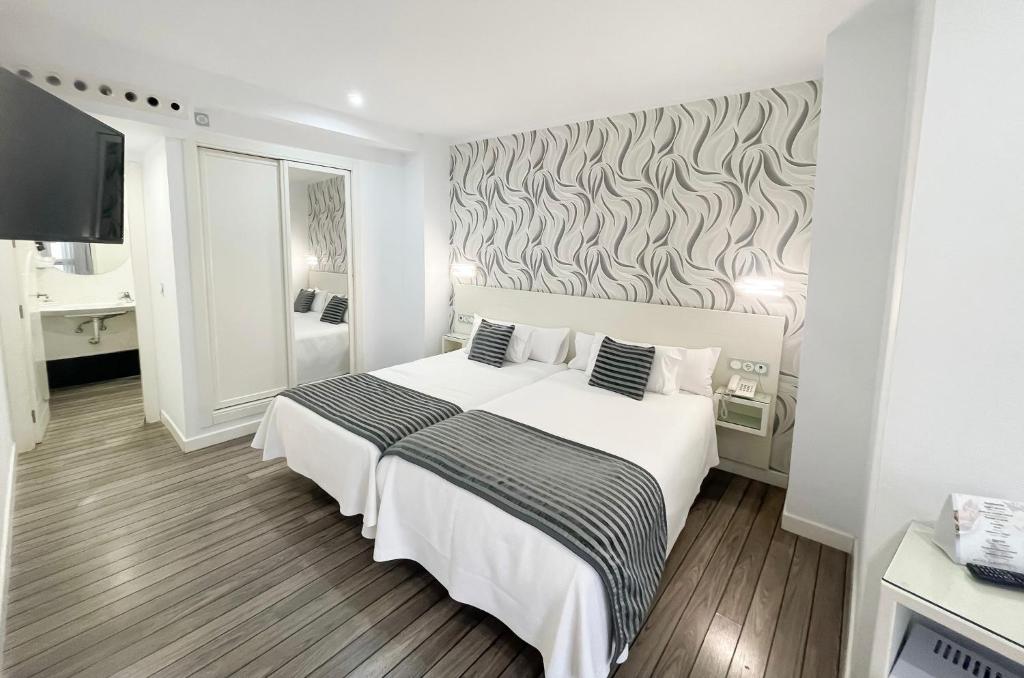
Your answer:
[279,374,462,452]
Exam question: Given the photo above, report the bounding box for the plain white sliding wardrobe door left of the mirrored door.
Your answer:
[199,149,289,411]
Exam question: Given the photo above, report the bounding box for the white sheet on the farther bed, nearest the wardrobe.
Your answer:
[252,351,565,538]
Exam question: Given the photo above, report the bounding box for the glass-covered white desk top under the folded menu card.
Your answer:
[883,522,1024,648]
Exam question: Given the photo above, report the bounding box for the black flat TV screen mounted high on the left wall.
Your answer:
[0,69,125,243]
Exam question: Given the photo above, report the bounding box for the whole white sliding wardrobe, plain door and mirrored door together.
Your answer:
[193,146,359,424]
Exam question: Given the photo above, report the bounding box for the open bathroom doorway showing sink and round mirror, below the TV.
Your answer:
[0,119,166,450]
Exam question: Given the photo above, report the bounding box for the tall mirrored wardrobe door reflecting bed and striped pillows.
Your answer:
[286,163,355,384]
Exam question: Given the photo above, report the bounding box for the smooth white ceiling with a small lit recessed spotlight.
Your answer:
[0,0,866,140]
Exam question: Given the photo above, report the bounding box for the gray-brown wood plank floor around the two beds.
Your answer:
[3,380,846,678]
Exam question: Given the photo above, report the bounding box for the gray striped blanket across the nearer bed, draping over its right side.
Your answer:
[382,410,667,656]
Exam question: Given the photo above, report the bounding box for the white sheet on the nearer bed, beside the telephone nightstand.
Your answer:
[374,370,718,678]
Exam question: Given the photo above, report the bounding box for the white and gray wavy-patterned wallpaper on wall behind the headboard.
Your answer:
[451,81,821,471]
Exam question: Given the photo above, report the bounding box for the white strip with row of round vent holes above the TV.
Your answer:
[0,63,191,120]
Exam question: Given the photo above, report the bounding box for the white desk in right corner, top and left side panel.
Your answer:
[870,522,1024,676]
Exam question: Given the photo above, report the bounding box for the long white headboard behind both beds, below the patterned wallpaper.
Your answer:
[455,285,785,395]
